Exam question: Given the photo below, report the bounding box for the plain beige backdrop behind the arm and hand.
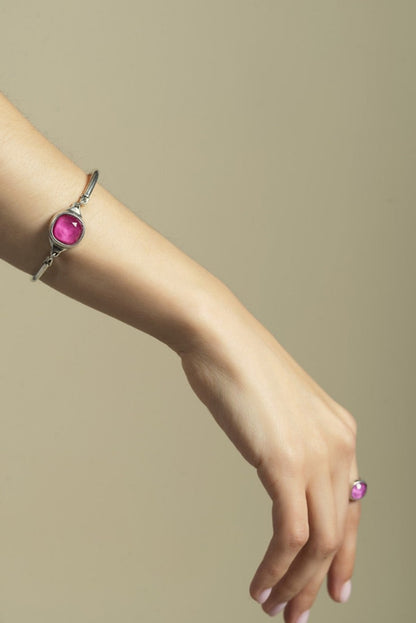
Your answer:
[0,0,416,623]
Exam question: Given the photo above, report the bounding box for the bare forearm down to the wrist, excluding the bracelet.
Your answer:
[0,96,235,352]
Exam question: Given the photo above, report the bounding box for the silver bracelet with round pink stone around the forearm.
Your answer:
[31,171,98,281]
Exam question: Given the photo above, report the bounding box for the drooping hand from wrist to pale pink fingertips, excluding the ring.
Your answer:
[178,296,361,623]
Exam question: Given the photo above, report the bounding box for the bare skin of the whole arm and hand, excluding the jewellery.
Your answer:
[0,90,361,623]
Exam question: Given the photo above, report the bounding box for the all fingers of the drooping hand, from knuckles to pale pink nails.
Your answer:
[250,414,360,623]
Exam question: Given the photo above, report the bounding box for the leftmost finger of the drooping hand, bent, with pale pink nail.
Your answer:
[250,479,309,603]
